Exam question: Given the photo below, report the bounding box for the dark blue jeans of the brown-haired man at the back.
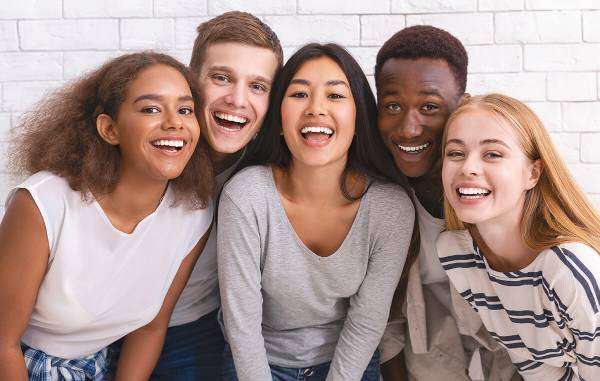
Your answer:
[111,310,225,381]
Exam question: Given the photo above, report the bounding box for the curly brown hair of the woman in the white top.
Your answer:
[9,51,214,209]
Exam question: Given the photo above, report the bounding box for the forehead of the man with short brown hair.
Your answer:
[200,42,277,79]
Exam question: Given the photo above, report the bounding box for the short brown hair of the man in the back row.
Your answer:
[190,11,283,72]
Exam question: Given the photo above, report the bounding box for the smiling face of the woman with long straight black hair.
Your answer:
[281,57,356,167]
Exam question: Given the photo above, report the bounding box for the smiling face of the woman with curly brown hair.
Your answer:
[106,64,200,181]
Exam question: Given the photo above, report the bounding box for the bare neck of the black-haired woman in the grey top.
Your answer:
[275,160,358,205]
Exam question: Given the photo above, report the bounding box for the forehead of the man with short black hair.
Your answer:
[377,58,458,97]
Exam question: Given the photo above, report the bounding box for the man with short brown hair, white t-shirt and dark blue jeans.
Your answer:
[152,12,283,381]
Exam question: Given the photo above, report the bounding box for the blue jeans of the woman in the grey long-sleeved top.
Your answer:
[221,344,380,381]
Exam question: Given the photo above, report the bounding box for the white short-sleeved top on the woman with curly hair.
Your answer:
[8,172,213,359]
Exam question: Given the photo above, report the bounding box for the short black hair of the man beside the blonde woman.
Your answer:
[375,25,469,94]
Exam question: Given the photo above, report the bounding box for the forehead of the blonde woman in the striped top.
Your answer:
[446,108,520,146]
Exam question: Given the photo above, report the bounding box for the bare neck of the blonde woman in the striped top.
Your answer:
[474,197,537,272]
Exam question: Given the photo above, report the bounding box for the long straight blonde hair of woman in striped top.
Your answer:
[442,94,600,253]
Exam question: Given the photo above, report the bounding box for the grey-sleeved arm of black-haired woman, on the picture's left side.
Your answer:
[217,191,271,381]
